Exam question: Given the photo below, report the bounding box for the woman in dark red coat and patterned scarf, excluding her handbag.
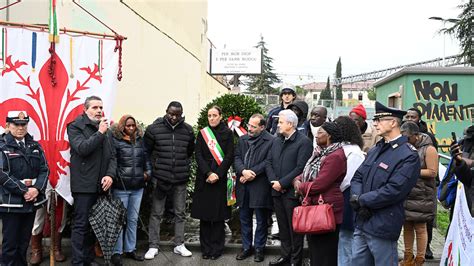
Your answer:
[294,122,346,266]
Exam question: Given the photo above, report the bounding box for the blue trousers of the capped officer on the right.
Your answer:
[352,228,398,266]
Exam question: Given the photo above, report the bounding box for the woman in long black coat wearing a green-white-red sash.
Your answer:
[191,106,234,260]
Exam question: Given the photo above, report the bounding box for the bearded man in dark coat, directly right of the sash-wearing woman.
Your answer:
[234,114,274,262]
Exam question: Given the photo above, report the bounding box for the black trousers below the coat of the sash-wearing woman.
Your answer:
[199,220,225,257]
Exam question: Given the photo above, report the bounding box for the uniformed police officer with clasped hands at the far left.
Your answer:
[0,111,49,265]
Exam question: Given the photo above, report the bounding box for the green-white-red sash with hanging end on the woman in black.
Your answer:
[201,127,237,206]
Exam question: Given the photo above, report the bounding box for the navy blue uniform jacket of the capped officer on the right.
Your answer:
[351,136,421,241]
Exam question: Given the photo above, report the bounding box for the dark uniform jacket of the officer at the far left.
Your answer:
[0,134,49,213]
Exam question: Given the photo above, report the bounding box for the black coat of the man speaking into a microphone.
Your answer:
[67,114,116,193]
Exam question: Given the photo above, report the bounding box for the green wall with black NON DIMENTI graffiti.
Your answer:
[376,73,474,152]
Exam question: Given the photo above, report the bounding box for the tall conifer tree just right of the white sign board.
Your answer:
[246,36,281,94]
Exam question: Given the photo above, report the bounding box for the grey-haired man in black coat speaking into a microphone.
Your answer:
[67,96,116,265]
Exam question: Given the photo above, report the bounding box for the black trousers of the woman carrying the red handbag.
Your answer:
[306,225,340,266]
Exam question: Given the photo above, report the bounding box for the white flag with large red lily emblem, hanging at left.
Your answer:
[0,26,118,204]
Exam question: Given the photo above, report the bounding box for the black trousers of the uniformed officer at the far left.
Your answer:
[1,211,36,266]
